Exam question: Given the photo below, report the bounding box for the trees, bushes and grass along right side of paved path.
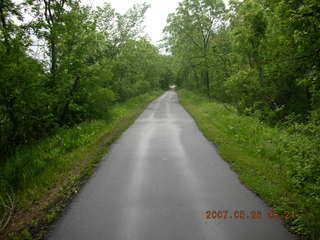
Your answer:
[164,0,320,240]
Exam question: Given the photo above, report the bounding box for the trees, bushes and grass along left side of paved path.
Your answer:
[0,0,173,239]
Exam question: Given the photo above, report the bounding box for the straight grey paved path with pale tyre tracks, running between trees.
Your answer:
[49,91,295,240]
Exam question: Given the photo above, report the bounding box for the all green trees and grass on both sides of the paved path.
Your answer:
[0,0,320,240]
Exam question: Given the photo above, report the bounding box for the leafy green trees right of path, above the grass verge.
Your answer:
[165,0,320,125]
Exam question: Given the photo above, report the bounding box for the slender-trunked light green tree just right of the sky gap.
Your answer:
[165,0,225,97]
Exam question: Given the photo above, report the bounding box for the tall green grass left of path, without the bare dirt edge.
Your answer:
[0,91,160,215]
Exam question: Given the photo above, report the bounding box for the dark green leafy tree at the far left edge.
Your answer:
[0,1,50,157]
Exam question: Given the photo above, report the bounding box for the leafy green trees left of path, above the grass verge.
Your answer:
[0,0,167,161]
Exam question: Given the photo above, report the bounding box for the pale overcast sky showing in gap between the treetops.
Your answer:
[82,0,228,44]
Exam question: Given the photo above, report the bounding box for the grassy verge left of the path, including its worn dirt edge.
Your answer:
[0,91,162,239]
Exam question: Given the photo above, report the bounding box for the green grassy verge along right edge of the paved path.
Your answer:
[178,90,320,240]
